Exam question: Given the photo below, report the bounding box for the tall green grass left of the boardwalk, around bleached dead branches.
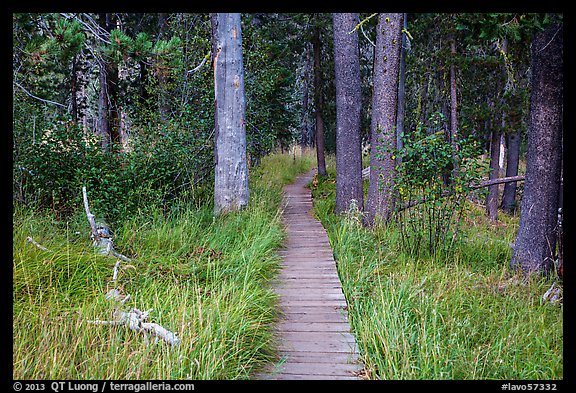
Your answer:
[12,149,313,379]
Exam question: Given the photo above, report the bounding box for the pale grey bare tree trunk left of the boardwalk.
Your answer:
[211,13,249,215]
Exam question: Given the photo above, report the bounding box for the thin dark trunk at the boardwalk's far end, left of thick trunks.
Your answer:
[312,28,327,176]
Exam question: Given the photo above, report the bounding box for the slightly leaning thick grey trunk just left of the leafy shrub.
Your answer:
[365,13,403,225]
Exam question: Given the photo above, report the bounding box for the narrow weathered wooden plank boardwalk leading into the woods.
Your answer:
[257,170,363,380]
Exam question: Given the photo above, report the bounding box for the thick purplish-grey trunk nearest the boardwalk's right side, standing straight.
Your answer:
[333,13,364,213]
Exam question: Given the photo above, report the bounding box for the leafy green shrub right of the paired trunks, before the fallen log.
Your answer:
[388,114,483,258]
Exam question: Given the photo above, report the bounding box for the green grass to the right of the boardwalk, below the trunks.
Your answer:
[314,161,564,380]
